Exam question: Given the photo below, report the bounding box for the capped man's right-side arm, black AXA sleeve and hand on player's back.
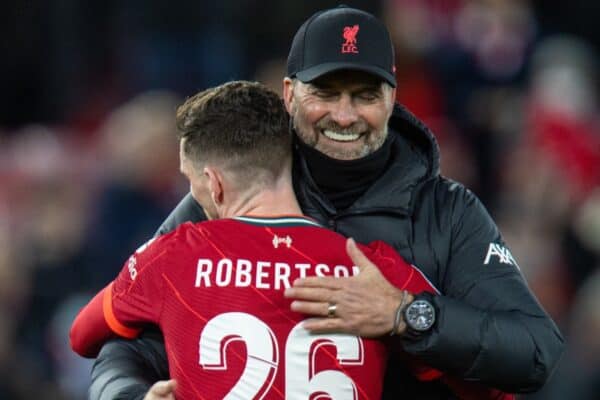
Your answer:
[284,181,564,393]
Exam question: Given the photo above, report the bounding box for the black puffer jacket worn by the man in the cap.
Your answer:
[91,107,563,399]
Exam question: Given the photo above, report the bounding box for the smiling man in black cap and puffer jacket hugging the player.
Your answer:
[90,3,563,399]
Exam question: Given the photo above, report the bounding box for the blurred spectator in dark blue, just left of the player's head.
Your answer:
[85,91,185,288]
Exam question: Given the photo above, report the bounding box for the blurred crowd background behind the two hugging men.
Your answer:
[0,0,600,400]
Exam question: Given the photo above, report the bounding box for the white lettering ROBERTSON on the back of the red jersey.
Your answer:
[194,258,360,289]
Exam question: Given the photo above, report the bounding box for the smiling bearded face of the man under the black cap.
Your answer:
[283,71,395,160]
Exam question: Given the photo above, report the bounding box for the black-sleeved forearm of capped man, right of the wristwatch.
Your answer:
[403,296,563,393]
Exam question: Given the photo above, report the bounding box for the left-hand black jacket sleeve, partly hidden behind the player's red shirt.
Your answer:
[89,194,206,400]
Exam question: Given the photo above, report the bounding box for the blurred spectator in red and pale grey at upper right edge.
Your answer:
[528,36,600,201]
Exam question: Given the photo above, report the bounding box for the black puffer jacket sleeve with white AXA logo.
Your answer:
[402,183,564,393]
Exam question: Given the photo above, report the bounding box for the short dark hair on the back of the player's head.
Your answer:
[176,81,292,184]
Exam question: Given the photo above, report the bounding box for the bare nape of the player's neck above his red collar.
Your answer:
[219,179,302,218]
